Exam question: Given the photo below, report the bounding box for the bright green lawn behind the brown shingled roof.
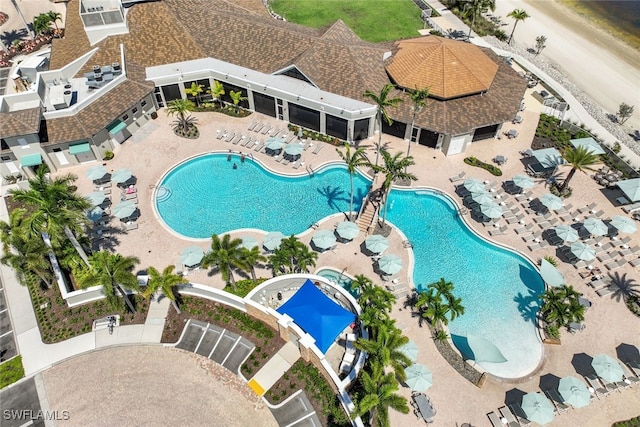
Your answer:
[271,0,424,42]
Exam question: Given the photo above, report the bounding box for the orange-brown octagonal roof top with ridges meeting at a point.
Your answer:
[387,36,498,99]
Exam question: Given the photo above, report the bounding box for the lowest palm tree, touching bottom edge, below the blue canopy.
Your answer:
[354,363,409,427]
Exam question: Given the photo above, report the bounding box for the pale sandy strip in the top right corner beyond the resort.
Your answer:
[495,0,640,129]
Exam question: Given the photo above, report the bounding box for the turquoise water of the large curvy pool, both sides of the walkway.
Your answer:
[156,154,544,378]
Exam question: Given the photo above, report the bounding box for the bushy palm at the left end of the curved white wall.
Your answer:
[76,251,140,313]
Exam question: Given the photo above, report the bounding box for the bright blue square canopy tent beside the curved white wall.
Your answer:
[277,279,356,353]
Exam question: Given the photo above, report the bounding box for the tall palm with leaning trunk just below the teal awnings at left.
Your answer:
[9,166,91,266]
